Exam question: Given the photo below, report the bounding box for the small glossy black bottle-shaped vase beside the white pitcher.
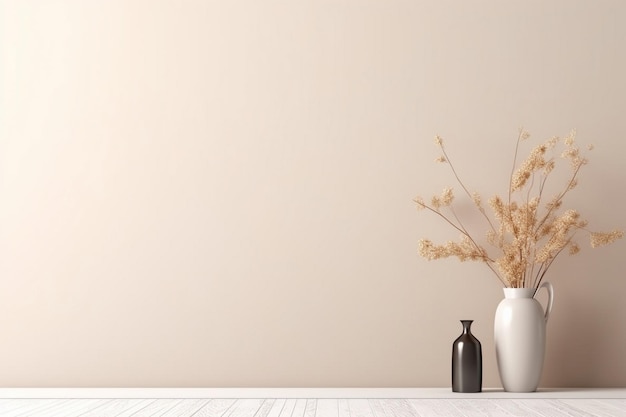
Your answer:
[452,320,483,392]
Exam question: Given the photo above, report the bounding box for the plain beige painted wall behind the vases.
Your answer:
[0,0,626,387]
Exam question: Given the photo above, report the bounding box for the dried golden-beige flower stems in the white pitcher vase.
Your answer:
[415,129,623,289]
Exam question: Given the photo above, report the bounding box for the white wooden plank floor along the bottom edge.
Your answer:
[0,398,626,417]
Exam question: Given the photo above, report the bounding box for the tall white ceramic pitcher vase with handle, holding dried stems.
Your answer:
[494,282,554,392]
